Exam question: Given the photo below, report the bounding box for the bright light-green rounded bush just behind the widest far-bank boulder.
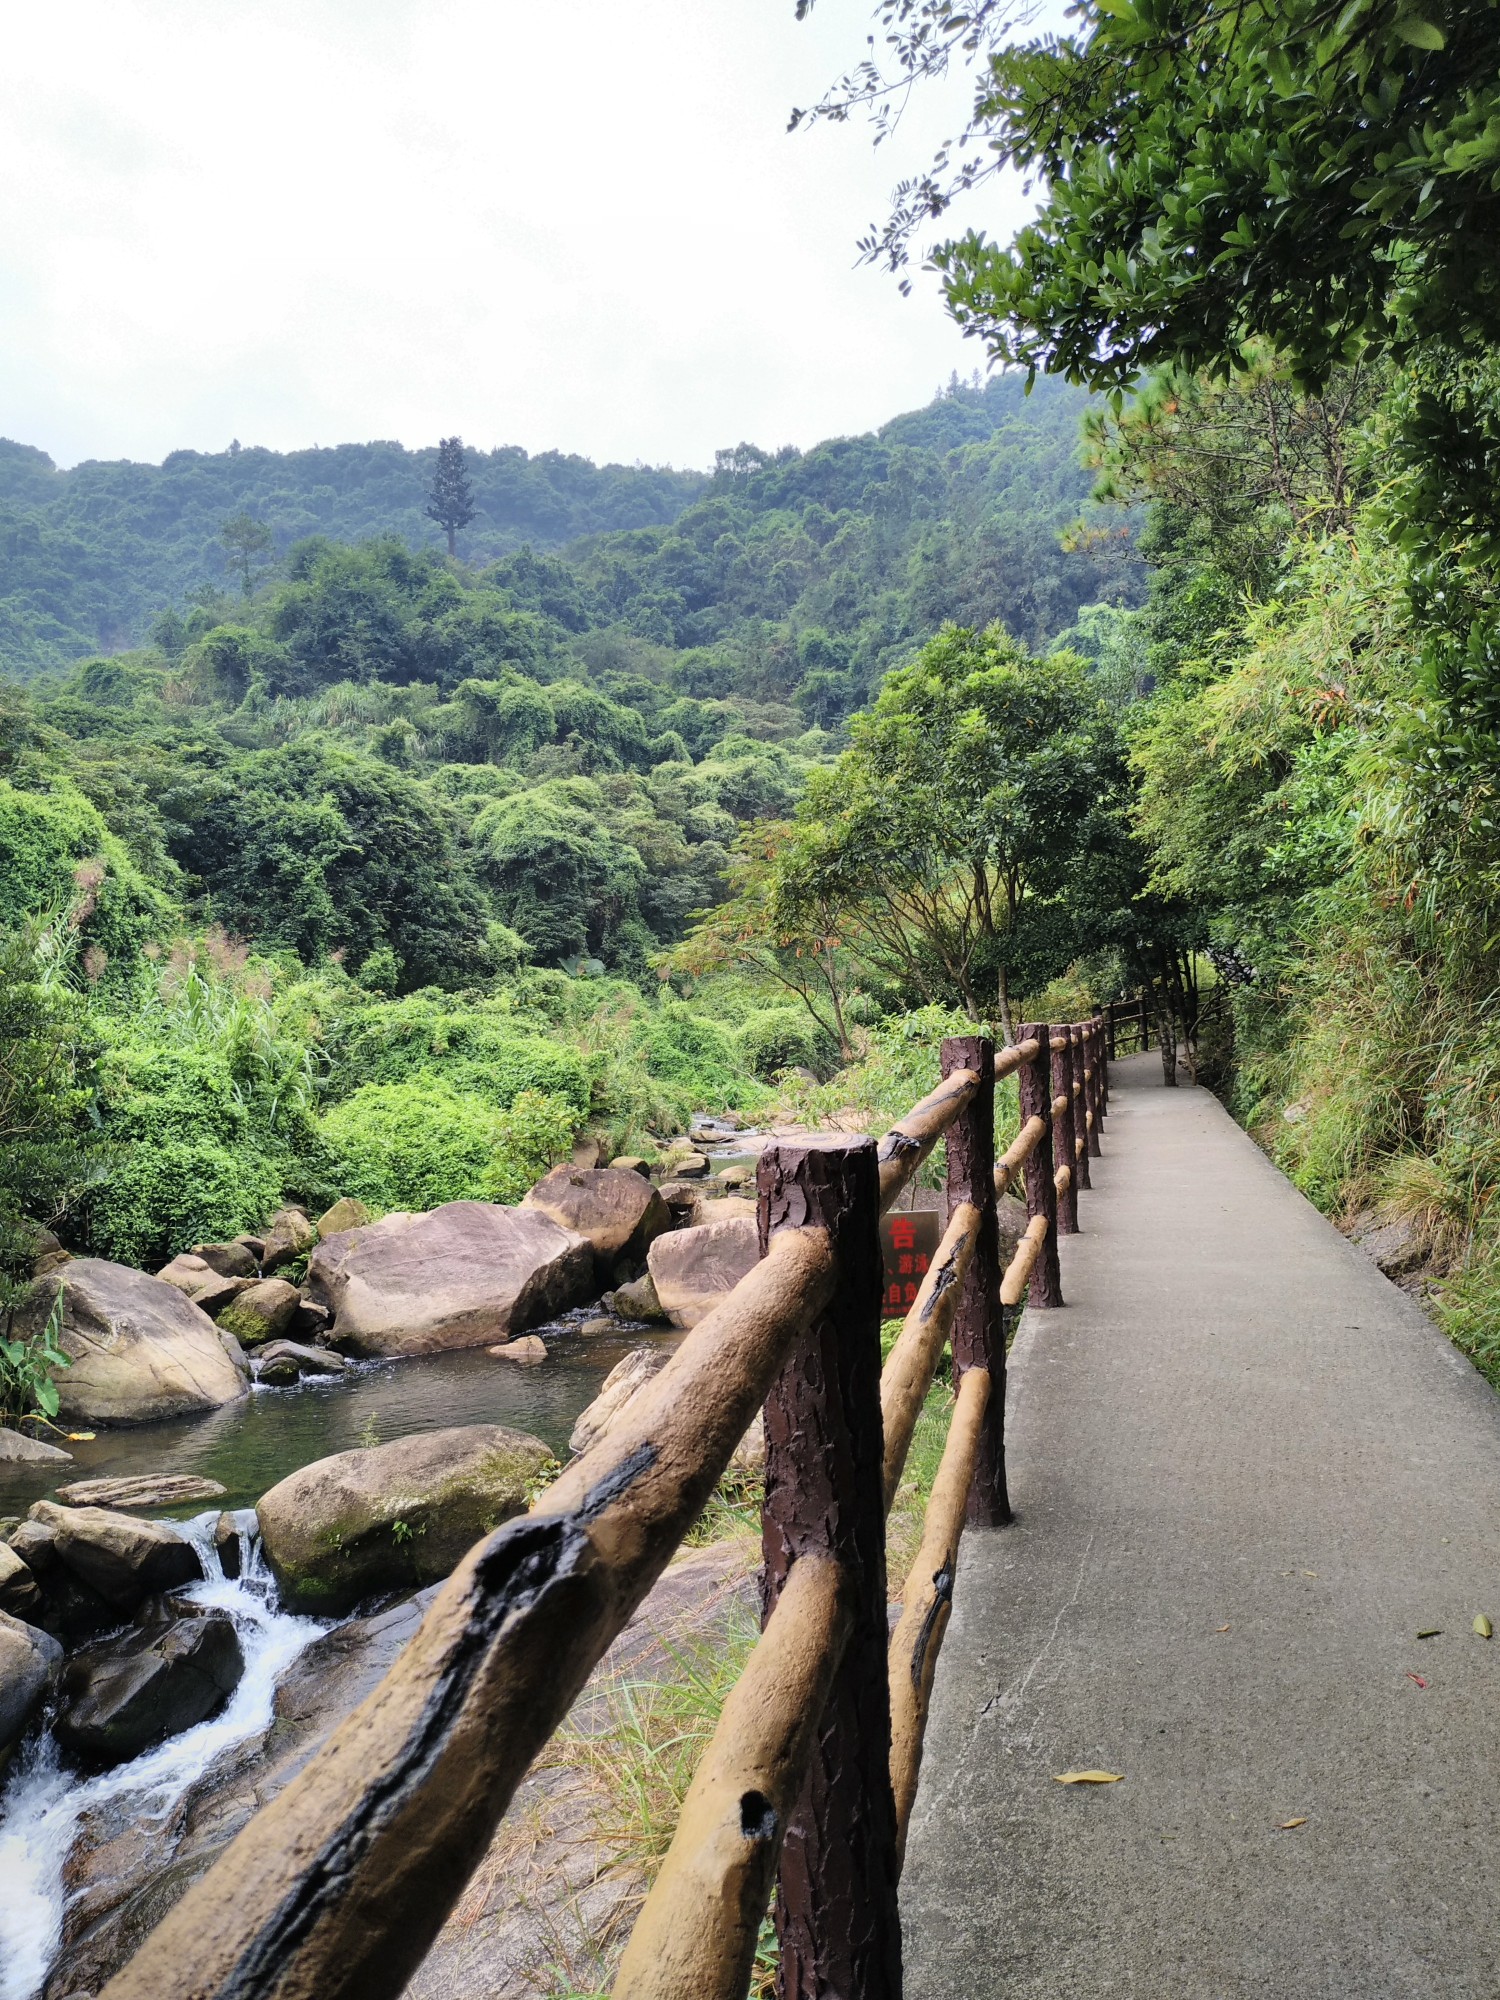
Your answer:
[322,1072,578,1210]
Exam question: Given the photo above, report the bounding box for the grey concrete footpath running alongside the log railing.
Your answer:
[902,1056,1500,2000]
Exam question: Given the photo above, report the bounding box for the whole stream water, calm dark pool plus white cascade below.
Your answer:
[0,1306,680,2000]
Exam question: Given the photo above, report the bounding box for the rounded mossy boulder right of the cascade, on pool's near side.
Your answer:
[256,1424,552,1618]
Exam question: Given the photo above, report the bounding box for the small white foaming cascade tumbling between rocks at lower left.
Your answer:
[0,1508,328,2000]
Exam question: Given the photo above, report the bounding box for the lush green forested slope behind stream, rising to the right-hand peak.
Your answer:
[0,376,1144,1260]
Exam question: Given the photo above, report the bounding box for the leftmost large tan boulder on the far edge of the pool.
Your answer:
[16,1256,246,1424]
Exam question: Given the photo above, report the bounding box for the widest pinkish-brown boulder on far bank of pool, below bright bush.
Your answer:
[308,1202,594,1354]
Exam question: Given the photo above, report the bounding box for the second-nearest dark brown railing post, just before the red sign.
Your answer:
[942,1034,1010,1528]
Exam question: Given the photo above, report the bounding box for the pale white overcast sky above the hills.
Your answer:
[0,0,1028,466]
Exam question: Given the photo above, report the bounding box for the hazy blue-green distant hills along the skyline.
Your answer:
[0,378,1120,680]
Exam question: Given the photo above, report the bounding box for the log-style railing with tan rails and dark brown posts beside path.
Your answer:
[100,1014,1112,2000]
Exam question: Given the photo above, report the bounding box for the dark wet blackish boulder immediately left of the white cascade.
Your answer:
[54,1608,244,1764]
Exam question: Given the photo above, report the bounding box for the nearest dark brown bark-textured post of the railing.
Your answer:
[764,1138,902,2000]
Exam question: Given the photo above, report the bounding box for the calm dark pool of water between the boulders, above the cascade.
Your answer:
[0,1306,682,1514]
